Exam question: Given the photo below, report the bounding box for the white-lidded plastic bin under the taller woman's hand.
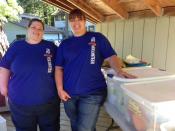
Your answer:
[106,67,175,111]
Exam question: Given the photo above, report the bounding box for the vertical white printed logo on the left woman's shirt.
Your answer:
[44,48,52,73]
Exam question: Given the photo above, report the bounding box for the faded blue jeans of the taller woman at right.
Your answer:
[64,94,106,131]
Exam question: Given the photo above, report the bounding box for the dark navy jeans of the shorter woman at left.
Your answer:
[9,100,60,131]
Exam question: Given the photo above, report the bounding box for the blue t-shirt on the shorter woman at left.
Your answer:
[0,40,57,105]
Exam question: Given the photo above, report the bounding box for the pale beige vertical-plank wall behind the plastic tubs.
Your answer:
[96,16,175,72]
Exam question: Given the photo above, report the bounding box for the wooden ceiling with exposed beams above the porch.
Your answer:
[43,0,175,23]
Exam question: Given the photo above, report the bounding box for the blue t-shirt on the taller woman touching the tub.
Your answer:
[56,32,116,96]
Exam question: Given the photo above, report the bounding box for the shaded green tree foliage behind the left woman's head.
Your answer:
[18,0,57,25]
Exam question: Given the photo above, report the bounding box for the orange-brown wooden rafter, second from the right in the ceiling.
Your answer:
[102,0,128,19]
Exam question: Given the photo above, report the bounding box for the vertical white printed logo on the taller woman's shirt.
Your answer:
[89,37,96,64]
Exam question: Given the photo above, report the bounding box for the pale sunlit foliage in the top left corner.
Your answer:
[0,0,23,23]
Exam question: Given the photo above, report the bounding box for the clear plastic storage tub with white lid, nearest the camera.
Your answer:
[122,79,175,131]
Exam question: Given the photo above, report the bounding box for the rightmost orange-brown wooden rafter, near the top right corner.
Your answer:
[144,0,163,16]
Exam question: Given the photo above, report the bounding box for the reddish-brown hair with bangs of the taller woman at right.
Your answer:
[69,9,86,20]
